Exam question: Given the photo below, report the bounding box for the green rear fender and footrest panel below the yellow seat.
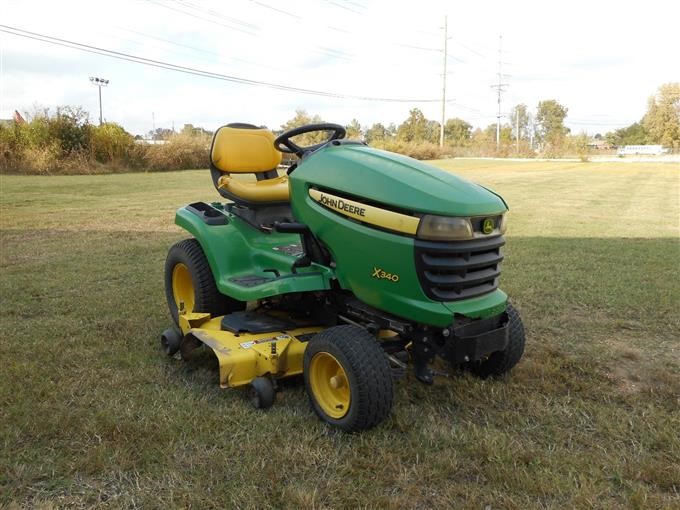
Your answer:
[175,208,334,301]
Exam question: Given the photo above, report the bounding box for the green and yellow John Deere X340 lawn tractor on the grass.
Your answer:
[161,124,524,431]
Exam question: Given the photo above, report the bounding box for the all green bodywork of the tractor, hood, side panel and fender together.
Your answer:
[176,141,507,327]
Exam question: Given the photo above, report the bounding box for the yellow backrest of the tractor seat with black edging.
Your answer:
[210,124,281,174]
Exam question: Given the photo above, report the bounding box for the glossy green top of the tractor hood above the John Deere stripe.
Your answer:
[291,143,507,216]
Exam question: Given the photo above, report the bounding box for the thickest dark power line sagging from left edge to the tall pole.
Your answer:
[0,25,452,103]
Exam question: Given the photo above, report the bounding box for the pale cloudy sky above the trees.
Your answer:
[0,0,680,135]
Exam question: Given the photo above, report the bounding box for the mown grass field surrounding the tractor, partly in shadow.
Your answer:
[0,160,680,509]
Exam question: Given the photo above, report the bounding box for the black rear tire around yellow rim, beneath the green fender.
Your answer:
[165,238,246,324]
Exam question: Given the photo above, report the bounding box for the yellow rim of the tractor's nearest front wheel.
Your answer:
[309,352,351,419]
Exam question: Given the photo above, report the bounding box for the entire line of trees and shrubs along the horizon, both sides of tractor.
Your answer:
[0,83,680,173]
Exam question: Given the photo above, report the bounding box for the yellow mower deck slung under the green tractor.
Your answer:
[179,312,323,388]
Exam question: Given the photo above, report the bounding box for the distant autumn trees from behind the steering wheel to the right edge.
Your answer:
[281,83,680,159]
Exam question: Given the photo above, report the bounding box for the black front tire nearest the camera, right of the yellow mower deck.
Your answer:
[303,326,394,432]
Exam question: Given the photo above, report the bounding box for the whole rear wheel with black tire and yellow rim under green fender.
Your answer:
[165,239,246,324]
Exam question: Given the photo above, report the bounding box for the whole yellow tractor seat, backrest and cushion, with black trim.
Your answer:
[210,124,289,205]
